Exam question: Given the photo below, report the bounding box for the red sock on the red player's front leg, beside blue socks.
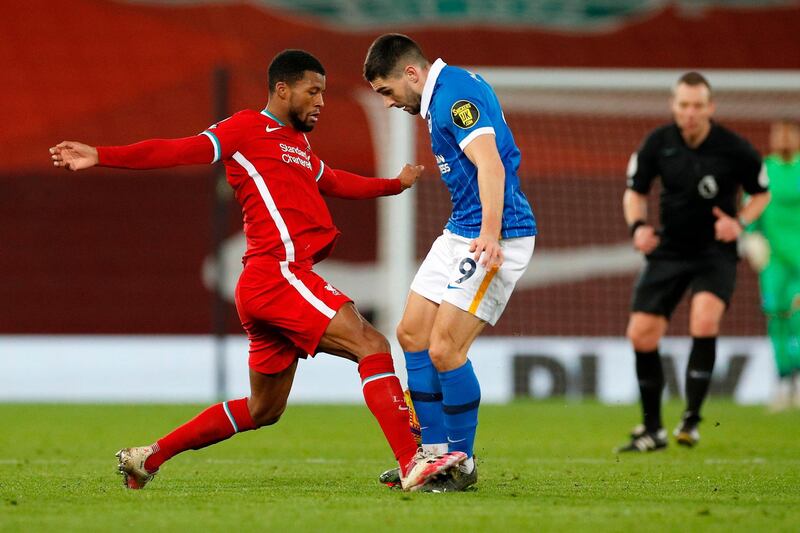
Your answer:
[358,353,417,476]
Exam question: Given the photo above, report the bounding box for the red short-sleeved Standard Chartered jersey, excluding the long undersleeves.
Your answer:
[203,110,339,262]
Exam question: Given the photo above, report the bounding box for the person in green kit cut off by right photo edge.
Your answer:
[742,120,800,409]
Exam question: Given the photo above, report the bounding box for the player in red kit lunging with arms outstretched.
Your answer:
[50,50,466,490]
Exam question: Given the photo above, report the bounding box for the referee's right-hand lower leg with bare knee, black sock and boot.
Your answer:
[675,291,726,446]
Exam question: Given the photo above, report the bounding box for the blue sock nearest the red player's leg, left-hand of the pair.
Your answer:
[404,350,447,444]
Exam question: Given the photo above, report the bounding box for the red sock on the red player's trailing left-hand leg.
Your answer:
[144,398,256,472]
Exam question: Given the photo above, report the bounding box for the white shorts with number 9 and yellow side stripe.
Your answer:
[411,230,536,326]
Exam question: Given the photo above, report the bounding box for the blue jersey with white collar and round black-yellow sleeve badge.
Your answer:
[420,59,536,239]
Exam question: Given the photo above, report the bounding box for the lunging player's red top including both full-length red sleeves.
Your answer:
[97,109,401,263]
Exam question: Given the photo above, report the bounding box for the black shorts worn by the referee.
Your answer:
[631,248,737,318]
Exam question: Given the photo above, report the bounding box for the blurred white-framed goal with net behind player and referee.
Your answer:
[368,67,800,337]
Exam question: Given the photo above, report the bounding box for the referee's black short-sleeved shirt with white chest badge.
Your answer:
[628,122,767,256]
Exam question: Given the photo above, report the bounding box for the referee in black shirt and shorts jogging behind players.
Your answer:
[616,72,769,452]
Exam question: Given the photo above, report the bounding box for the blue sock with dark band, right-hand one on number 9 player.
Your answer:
[439,359,481,457]
